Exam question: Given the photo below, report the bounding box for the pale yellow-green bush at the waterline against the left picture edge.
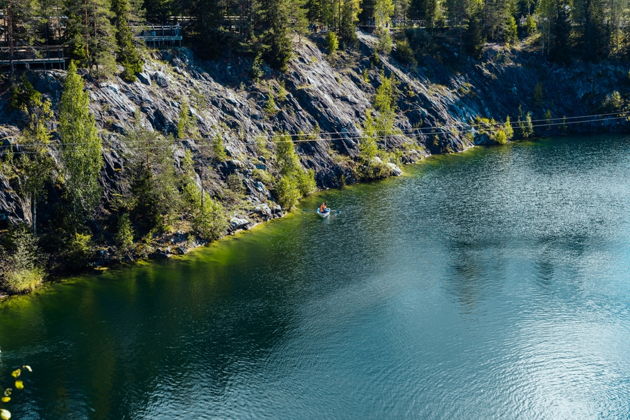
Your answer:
[0,228,45,293]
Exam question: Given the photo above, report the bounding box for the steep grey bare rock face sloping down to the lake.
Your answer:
[0,34,629,229]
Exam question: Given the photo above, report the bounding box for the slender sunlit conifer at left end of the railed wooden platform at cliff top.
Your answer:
[112,0,143,82]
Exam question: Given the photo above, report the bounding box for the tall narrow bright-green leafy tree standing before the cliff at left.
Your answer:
[59,61,103,221]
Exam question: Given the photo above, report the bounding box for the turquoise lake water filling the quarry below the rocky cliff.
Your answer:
[0,137,630,419]
